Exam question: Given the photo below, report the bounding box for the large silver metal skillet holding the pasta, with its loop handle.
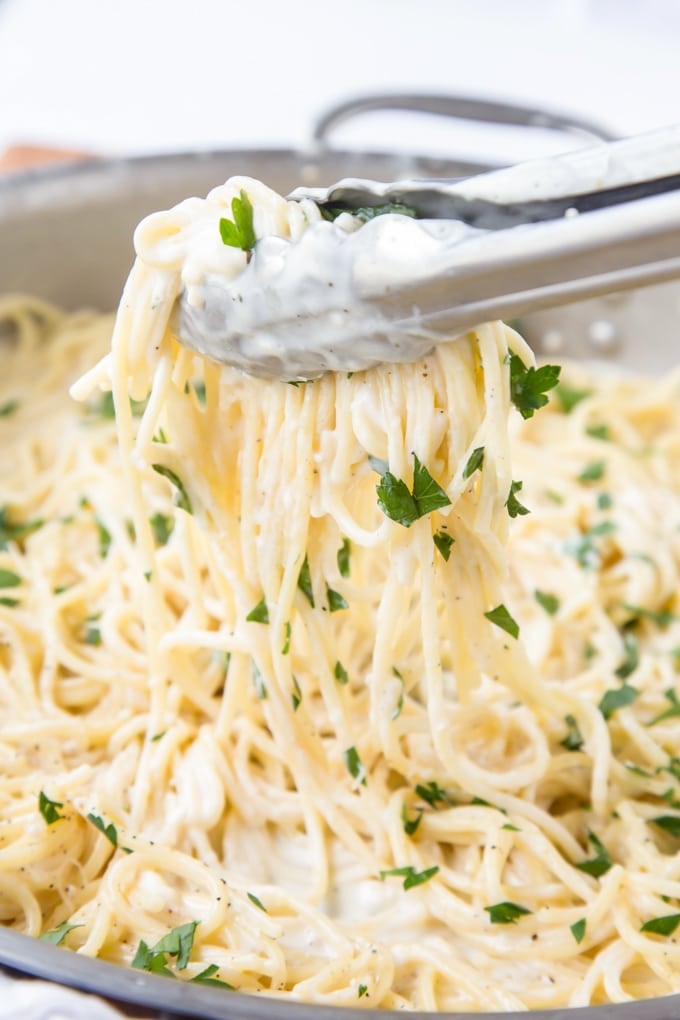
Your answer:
[0,96,680,1020]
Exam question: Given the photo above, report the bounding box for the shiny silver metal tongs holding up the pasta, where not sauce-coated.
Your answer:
[176,125,680,377]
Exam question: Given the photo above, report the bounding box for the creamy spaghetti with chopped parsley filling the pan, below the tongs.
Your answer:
[0,179,680,1011]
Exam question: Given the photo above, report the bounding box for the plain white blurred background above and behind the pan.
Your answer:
[0,0,680,169]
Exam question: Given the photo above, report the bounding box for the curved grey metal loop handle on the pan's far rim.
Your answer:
[312,93,618,150]
